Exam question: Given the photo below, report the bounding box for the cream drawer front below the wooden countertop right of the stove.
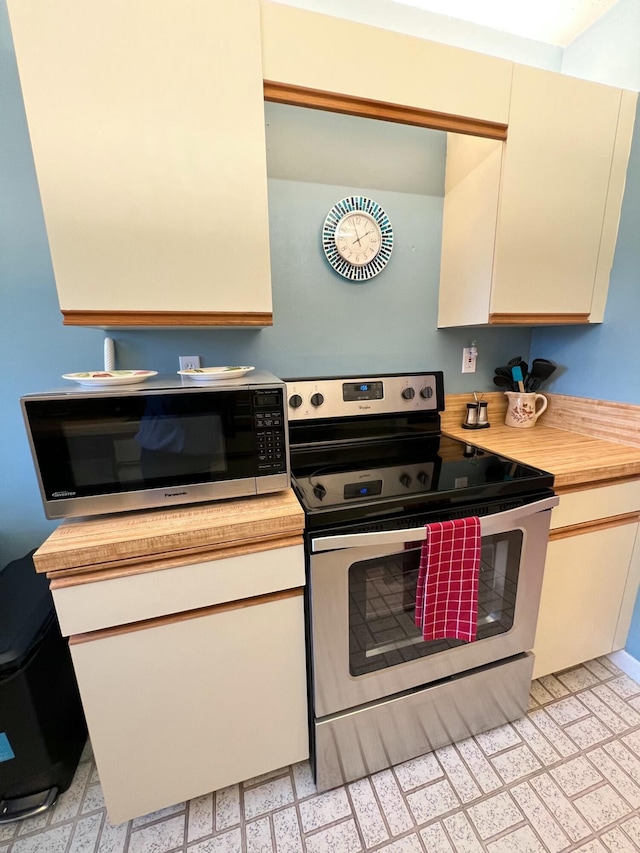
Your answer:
[551,480,640,530]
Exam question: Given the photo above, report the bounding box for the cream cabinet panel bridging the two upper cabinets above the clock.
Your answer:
[262,0,513,122]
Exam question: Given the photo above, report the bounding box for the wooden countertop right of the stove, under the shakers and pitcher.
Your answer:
[442,413,640,489]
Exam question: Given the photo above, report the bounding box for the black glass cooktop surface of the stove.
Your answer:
[291,435,553,527]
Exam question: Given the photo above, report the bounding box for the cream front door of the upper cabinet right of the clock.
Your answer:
[490,65,622,322]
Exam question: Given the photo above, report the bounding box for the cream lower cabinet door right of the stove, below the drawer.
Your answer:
[533,523,638,678]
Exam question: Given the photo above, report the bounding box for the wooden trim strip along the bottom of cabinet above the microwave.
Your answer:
[61,310,273,329]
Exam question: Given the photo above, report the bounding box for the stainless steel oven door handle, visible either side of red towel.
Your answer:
[311,495,560,554]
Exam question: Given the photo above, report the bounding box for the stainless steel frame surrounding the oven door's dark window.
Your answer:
[309,498,553,717]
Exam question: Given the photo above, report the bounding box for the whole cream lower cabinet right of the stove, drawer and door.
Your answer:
[533,481,640,678]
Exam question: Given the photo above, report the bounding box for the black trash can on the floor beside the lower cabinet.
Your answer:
[0,551,87,823]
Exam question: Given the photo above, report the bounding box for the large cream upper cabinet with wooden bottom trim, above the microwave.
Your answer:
[9,0,272,326]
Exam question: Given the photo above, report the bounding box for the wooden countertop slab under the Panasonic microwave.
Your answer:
[33,489,304,578]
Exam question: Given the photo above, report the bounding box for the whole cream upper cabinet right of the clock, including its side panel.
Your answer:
[438,65,637,327]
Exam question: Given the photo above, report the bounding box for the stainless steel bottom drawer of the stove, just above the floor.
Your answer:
[314,652,534,791]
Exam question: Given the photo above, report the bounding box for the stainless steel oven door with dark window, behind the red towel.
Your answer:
[310,497,558,718]
